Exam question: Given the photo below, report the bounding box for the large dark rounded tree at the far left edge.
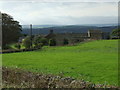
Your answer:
[2,13,22,48]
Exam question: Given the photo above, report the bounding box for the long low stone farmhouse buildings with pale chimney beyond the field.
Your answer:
[45,30,109,46]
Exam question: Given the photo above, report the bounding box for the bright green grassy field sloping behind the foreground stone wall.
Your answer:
[3,40,118,85]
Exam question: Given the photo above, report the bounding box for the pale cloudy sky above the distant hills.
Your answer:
[0,0,118,25]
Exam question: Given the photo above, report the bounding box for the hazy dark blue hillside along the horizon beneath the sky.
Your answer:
[22,25,117,34]
